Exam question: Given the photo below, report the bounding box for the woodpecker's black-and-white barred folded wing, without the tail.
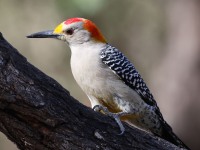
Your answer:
[100,44,155,106]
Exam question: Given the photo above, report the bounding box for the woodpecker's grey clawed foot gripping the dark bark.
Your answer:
[93,105,127,135]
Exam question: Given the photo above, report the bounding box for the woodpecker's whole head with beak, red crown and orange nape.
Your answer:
[27,18,106,45]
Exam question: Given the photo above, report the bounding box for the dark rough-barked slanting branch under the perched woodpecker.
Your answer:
[0,34,179,150]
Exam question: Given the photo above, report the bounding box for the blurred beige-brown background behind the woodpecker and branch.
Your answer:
[0,0,200,150]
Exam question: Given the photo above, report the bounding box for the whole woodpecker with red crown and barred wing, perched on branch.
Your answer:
[27,18,188,149]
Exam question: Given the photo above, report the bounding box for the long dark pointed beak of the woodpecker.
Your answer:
[26,30,60,39]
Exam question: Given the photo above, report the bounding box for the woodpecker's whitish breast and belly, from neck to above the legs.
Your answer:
[71,43,145,112]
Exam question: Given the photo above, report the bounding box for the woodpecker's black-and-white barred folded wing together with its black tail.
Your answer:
[100,44,189,149]
